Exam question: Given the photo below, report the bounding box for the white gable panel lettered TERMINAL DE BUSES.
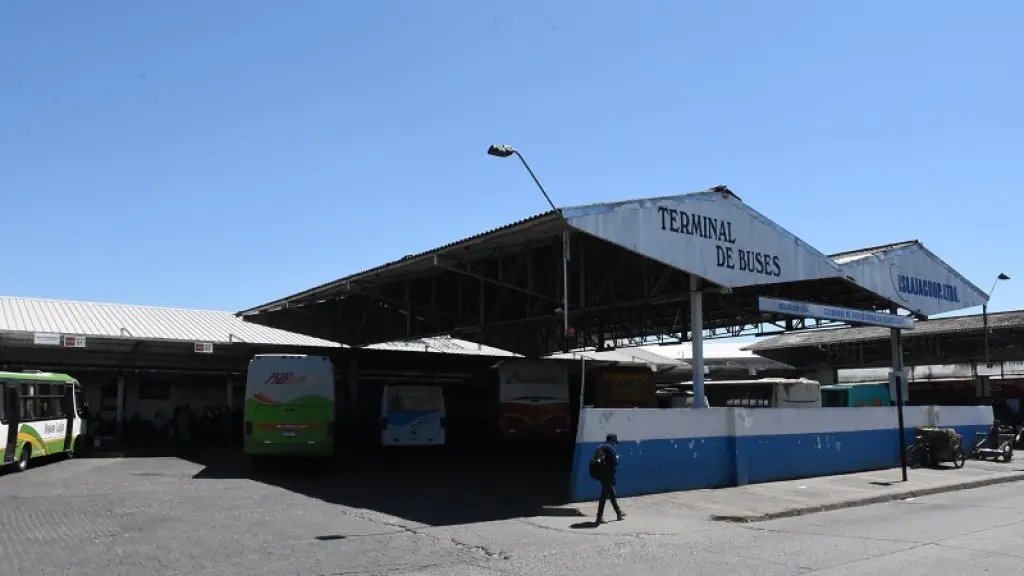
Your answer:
[563,191,840,288]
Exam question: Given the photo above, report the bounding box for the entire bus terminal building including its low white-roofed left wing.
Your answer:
[0,187,1007,499]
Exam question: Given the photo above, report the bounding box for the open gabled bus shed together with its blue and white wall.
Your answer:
[240,187,991,499]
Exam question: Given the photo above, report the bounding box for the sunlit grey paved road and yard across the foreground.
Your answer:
[0,458,1024,576]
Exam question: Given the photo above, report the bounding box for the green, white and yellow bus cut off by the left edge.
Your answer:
[0,371,85,471]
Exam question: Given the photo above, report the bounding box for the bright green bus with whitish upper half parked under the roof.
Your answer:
[244,354,335,457]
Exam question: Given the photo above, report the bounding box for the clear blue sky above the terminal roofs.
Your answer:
[0,0,1024,311]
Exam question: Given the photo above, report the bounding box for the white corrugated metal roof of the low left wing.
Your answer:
[0,296,341,347]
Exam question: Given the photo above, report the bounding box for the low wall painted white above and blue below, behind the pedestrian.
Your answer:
[571,406,992,501]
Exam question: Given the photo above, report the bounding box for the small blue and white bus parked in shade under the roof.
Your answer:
[381,384,444,446]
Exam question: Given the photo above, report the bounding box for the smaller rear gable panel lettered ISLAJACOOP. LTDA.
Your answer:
[842,243,987,316]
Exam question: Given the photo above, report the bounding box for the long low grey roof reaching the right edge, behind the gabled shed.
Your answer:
[744,311,1024,353]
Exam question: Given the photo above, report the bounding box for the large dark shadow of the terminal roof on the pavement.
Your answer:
[189,448,582,526]
